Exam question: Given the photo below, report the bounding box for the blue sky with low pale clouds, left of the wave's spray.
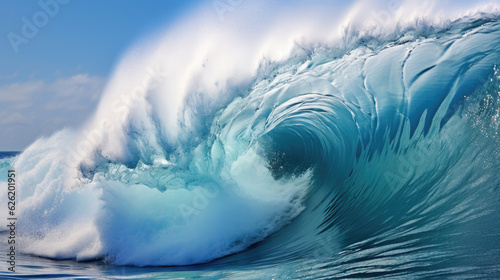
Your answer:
[0,0,203,151]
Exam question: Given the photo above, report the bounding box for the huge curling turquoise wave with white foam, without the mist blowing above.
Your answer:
[0,1,500,279]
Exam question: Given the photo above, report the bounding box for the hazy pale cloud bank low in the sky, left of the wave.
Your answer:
[0,74,104,151]
